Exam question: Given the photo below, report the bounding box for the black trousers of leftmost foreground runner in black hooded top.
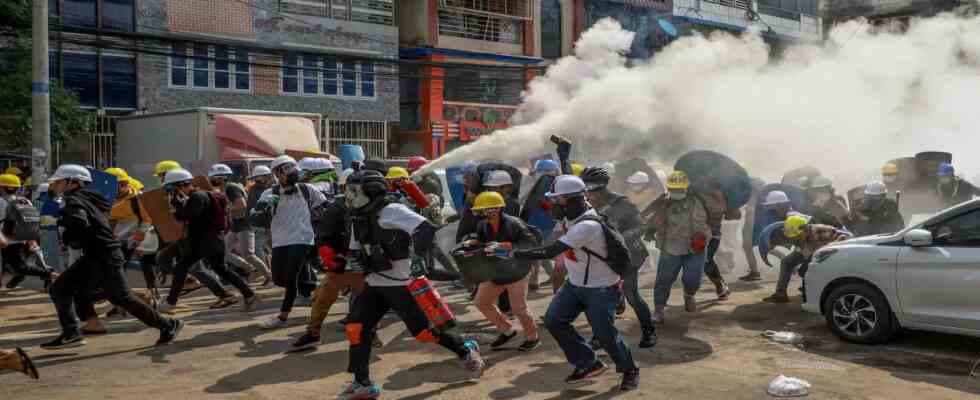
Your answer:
[49,249,173,333]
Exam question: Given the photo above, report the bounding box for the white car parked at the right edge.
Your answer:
[803,199,980,344]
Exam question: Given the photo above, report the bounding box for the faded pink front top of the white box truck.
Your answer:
[214,114,320,160]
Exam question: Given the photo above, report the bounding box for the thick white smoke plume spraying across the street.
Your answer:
[427,15,980,188]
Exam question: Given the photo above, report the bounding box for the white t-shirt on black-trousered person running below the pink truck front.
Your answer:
[259,183,327,248]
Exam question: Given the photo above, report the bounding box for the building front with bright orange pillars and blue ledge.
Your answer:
[397,0,541,157]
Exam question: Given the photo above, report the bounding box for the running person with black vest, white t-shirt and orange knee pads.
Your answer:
[337,170,484,400]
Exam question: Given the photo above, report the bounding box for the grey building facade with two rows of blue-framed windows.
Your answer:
[51,0,399,166]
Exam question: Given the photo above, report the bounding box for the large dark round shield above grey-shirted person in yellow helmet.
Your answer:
[674,150,752,210]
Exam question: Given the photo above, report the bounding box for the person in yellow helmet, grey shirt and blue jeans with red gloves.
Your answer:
[645,171,711,323]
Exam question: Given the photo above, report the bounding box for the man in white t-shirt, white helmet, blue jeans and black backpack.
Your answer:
[513,175,640,391]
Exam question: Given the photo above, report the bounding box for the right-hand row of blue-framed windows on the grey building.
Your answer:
[282,54,377,97]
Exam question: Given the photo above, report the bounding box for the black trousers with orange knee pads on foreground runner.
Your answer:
[346,284,469,382]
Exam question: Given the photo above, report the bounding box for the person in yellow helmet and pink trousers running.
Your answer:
[472,192,541,351]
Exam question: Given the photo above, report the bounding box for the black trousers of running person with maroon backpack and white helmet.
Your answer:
[167,236,255,304]
